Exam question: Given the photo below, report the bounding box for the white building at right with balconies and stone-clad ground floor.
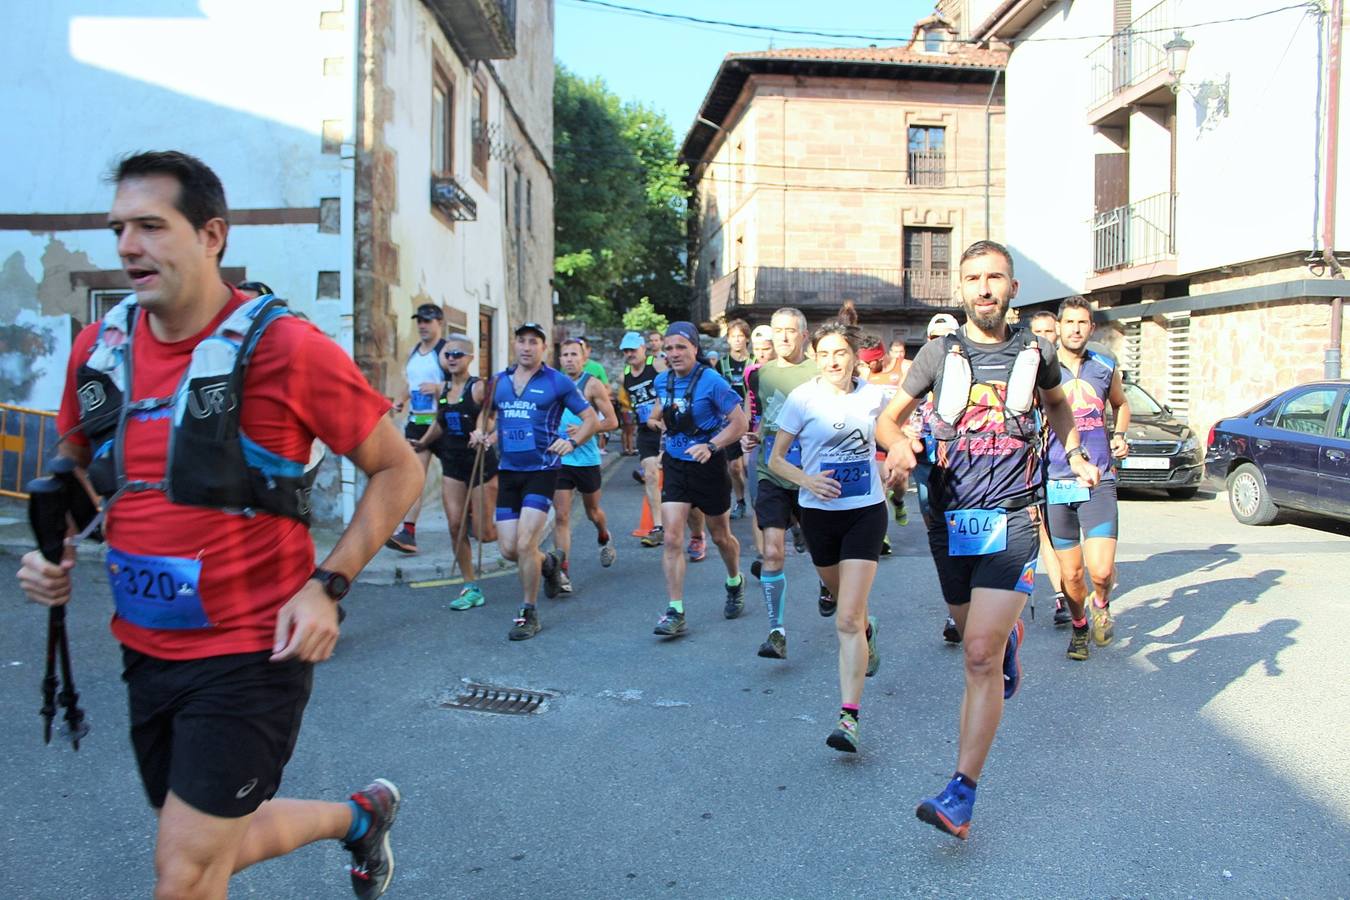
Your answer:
[977,0,1350,436]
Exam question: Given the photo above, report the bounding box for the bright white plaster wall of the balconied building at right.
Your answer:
[1007,0,1328,304]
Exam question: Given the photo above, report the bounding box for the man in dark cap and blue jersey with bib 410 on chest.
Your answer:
[470,322,599,641]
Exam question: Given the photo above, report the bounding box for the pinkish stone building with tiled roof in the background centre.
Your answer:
[682,30,1004,349]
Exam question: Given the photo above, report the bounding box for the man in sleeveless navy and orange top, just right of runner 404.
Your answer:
[1045,297,1130,660]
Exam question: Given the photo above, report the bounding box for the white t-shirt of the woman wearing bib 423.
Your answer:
[778,376,886,510]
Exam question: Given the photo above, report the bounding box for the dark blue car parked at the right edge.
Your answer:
[1204,381,1350,525]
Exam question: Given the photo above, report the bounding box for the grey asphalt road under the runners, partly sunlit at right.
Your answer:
[0,472,1350,900]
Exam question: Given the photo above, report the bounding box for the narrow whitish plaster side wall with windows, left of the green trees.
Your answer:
[385,0,508,369]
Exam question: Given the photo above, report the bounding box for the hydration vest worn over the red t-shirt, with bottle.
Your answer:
[76,294,324,525]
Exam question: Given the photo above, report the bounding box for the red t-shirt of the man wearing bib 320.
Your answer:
[57,291,389,660]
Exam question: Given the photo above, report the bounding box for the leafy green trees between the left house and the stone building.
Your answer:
[554,66,689,327]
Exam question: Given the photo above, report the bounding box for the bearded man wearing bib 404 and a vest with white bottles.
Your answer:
[876,240,1099,839]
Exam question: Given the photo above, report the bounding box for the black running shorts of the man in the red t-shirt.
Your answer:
[122,646,315,819]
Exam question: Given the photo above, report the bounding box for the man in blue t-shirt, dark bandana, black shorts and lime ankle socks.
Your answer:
[647,322,747,637]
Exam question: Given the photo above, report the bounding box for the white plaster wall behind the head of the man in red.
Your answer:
[0,0,352,327]
